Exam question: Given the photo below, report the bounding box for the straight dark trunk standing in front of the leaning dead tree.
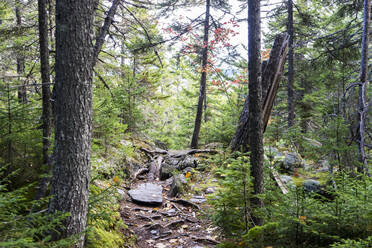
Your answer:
[248,0,264,225]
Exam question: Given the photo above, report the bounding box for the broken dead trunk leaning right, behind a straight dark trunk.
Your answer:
[231,33,289,152]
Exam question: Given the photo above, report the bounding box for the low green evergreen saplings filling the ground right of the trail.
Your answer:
[212,157,372,247]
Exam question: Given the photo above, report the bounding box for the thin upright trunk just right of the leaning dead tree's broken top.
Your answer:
[287,0,294,127]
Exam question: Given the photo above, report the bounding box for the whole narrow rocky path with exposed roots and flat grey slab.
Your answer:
[120,149,218,248]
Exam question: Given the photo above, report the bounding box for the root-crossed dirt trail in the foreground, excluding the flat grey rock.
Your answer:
[121,179,218,248]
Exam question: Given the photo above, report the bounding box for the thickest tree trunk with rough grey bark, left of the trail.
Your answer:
[49,0,95,247]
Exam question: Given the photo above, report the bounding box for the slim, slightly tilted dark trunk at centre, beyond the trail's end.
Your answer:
[190,0,210,148]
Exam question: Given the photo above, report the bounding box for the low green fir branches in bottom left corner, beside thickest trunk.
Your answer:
[0,167,74,248]
